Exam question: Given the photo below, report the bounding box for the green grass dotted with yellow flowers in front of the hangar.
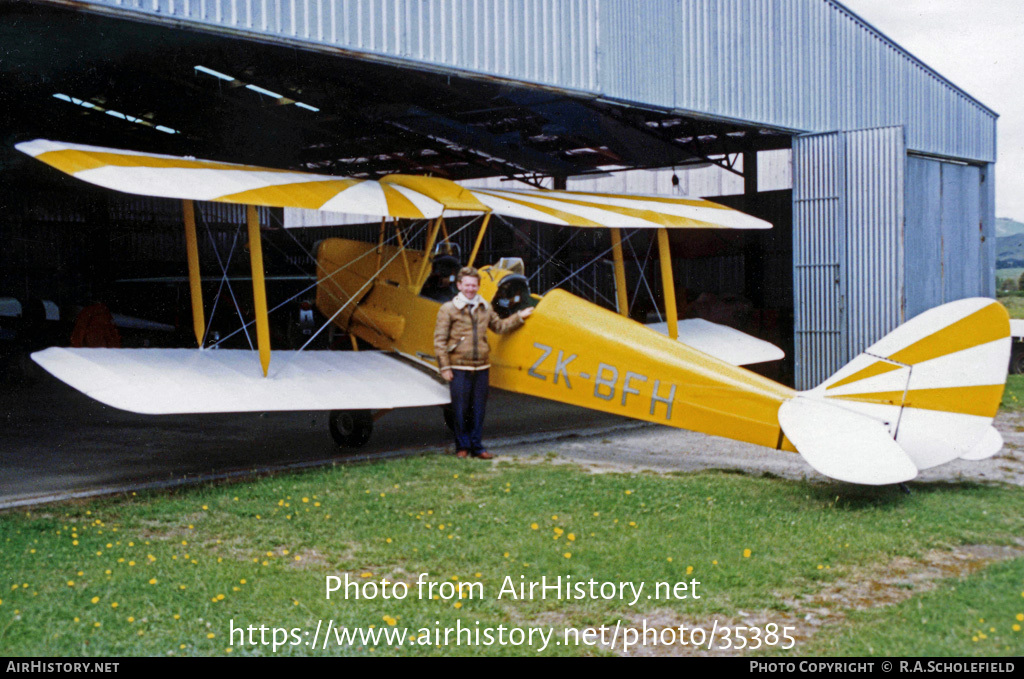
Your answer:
[0,456,1024,656]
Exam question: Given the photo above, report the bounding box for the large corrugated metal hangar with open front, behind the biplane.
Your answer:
[0,0,996,388]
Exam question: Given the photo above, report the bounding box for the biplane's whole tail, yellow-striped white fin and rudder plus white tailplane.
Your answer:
[779,298,1011,484]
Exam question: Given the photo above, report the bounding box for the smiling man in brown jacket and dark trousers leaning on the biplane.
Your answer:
[434,266,534,460]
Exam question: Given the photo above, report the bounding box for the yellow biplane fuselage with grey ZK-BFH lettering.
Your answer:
[316,239,796,451]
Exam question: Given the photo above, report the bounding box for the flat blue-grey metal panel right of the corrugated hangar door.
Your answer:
[905,157,995,319]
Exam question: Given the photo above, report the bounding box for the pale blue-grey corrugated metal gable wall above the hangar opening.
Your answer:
[75,0,995,163]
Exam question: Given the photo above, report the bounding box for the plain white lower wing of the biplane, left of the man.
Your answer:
[32,347,450,415]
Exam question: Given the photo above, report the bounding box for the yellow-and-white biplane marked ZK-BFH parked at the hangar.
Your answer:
[16,139,1011,485]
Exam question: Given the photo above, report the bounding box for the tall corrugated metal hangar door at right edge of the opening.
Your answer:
[793,127,906,389]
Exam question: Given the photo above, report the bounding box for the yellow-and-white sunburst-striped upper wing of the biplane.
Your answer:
[15,139,771,228]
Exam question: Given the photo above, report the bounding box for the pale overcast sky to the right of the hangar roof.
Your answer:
[839,0,1024,222]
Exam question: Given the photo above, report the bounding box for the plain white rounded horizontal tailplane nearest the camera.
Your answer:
[778,396,918,485]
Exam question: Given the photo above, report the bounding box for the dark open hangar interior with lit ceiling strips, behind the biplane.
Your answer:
[0,3,792,379]
